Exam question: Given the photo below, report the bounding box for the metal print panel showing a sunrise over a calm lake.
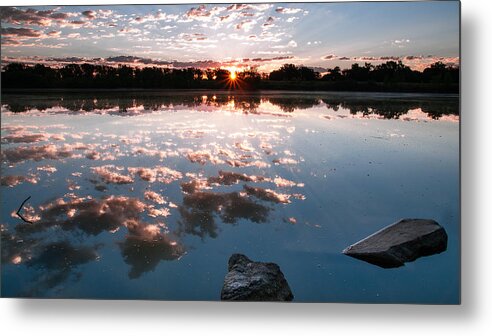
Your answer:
[0,1,460,304]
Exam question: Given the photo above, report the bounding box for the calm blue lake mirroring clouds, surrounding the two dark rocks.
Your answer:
[1,91,460,304]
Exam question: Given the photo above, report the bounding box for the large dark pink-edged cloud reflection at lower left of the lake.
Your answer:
[1,195,186,288]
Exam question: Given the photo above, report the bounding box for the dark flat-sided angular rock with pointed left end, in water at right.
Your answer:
[342,219,448,268]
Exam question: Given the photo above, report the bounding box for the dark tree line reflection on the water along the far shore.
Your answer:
[2,91,459,120]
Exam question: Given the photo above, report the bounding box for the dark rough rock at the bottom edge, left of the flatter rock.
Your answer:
[220,254,294,301]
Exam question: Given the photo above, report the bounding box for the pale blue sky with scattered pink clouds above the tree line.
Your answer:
[0,1,459,72]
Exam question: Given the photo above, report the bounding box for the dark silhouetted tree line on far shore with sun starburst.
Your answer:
[1,61,459,89]
